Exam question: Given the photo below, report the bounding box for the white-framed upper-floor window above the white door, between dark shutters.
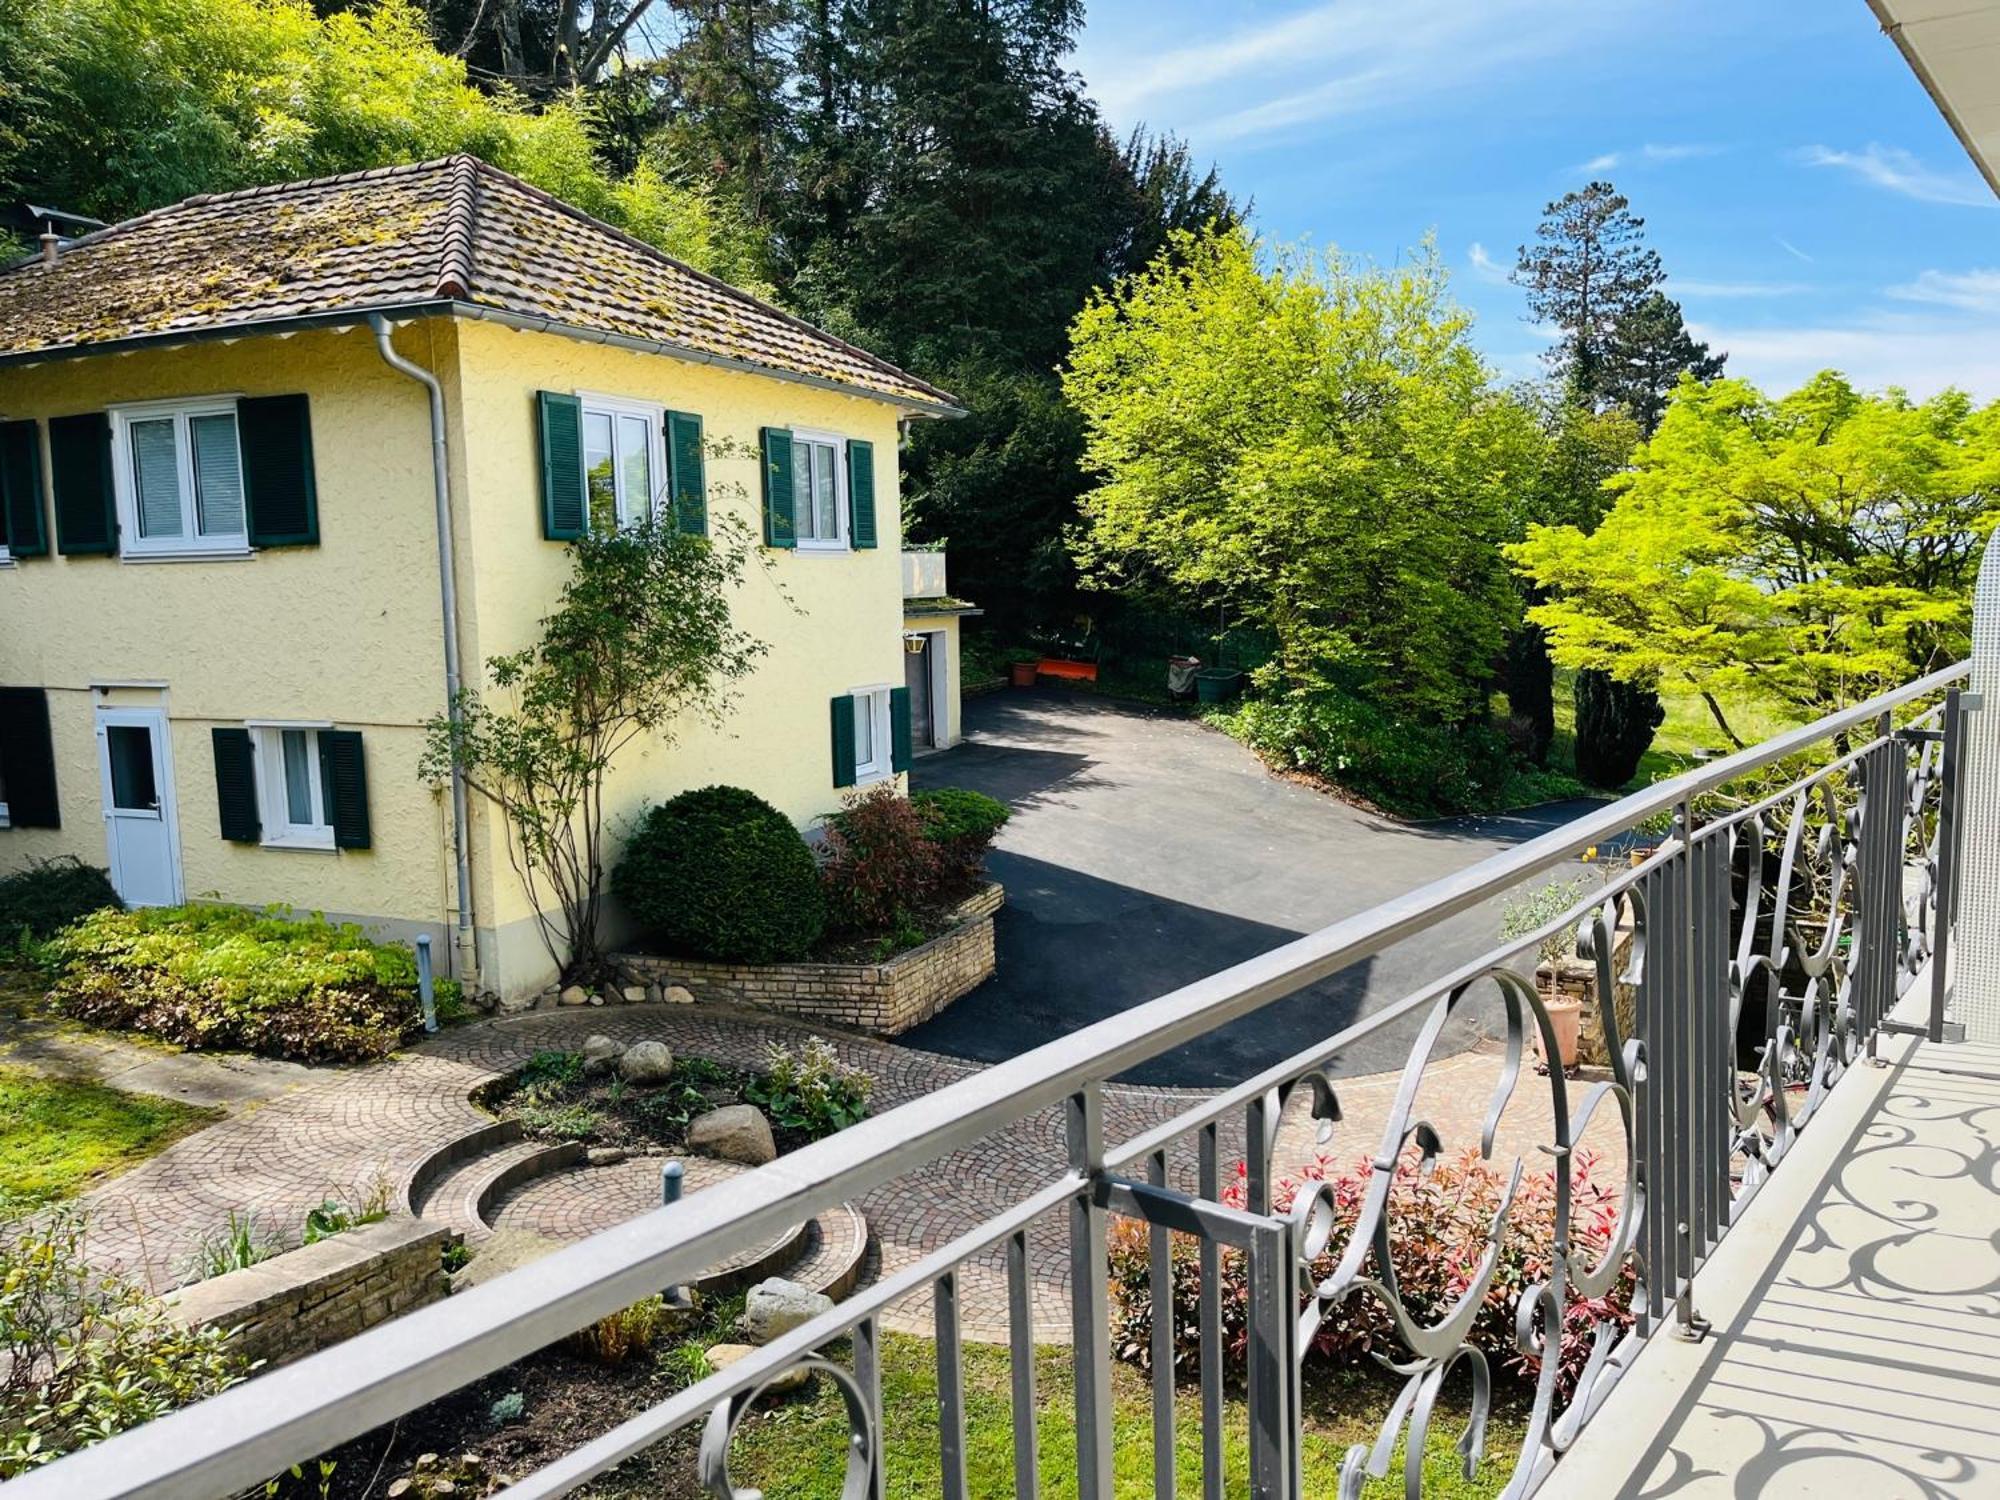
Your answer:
[112,400,250,556]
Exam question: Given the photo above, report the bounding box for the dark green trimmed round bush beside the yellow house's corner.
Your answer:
[612,786,826,964]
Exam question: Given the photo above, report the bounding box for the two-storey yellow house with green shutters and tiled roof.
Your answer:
[0,156,958,994]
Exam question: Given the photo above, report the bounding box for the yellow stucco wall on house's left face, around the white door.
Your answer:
[0,324,452,940]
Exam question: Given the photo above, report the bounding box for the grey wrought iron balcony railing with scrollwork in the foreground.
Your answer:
[6,668,1968,1500]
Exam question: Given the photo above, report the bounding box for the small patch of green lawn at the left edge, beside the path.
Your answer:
[0,1068,222,1218]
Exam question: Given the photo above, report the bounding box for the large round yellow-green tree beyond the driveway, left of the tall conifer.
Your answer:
[1064,230,1536,722]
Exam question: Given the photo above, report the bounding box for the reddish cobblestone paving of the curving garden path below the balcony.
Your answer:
[66,1006,1592,1340]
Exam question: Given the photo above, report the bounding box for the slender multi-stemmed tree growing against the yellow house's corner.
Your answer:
[422,518,764,978]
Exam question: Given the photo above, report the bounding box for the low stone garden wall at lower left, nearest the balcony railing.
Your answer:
[164,1216,458,1364]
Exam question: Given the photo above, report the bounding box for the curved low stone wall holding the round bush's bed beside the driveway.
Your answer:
[616,884,1006,1036]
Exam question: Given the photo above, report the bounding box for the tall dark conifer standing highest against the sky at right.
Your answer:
[1514,182,1666,400]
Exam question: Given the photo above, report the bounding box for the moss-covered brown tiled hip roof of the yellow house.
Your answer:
[0,156,956,406]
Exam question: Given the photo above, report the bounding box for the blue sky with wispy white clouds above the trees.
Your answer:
[1076,0,2000,400]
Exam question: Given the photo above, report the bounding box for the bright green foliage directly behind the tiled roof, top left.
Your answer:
[0,0,764,288]
